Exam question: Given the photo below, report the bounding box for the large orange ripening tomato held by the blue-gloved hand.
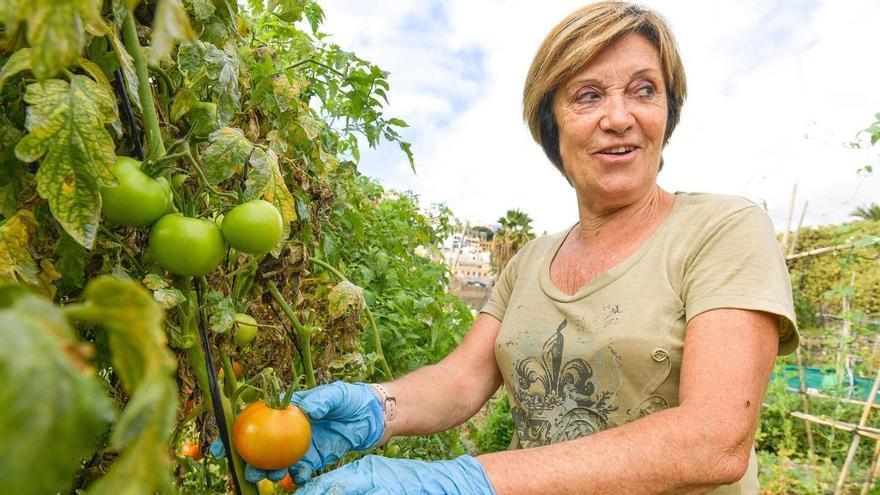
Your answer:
[232,400,312,471]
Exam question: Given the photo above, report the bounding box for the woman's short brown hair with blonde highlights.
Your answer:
[523,2,687,175]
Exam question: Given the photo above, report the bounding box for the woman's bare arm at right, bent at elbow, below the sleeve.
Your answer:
[478,309,779,495]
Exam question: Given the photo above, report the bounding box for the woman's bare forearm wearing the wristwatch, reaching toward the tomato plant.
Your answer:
[381,314,502,443]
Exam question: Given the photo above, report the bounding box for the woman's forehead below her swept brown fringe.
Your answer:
[569,33,662,83]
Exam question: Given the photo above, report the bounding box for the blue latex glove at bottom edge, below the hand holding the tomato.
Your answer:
[294,455,495,495]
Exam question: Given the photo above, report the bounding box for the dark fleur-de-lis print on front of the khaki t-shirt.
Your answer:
[511,319,619,448]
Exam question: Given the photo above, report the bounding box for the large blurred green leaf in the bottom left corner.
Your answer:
[0,294,113,493]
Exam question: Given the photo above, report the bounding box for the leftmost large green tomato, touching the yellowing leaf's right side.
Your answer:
[101,156,173,227]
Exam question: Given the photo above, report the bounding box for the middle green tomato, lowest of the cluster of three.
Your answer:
[150,213,226,277]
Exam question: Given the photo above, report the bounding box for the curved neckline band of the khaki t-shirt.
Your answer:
[539,191,685,302]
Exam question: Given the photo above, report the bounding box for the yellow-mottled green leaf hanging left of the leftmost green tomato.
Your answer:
[15,75,116,249]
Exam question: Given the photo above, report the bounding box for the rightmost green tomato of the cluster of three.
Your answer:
[222,199,284,254]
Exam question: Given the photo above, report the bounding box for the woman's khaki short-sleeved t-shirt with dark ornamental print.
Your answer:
[481,193,798,494]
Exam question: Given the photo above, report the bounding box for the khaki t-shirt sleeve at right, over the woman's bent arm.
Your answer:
[682,205,798,355]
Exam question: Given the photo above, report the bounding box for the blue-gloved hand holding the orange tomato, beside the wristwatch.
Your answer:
[289,381,385,485]
